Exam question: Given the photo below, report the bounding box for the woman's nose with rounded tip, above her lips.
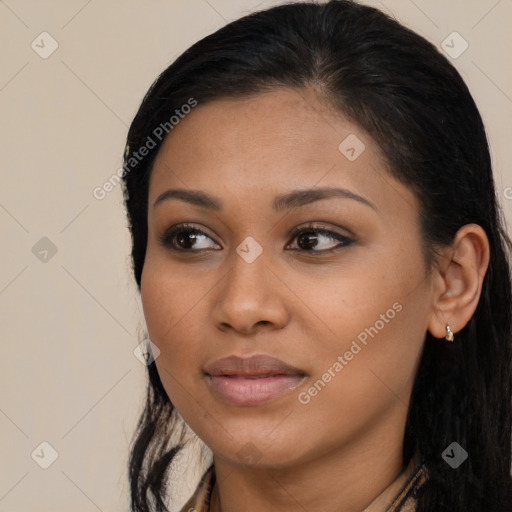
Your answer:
[213,248,289,335]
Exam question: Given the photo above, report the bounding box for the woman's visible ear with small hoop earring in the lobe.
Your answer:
[427,224,489,338]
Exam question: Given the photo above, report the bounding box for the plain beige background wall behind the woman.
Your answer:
[0,0,512,512]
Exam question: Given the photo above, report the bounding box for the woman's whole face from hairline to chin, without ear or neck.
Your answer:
[141,89,432,467]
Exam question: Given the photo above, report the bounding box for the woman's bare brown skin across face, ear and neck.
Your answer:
[141,89,489,512]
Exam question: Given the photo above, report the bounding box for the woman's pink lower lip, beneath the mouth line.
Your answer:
[207,375,305,405]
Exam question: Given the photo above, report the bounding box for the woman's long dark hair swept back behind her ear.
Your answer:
[122,0,512,512]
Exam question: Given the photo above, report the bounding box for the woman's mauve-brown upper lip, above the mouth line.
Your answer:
[204,354,305,376]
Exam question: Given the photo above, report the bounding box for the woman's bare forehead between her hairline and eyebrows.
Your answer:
[146,89,414,218]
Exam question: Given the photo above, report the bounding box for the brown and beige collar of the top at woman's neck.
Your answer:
[180,458,427,512]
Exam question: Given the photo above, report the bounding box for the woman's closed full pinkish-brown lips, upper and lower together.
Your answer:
[204,355,306,406]
